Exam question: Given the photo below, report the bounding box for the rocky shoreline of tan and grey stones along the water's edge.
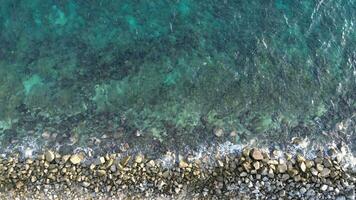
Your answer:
[0,147,356,200]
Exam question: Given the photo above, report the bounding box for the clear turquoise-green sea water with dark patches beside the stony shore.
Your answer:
[0,0,356,155]
